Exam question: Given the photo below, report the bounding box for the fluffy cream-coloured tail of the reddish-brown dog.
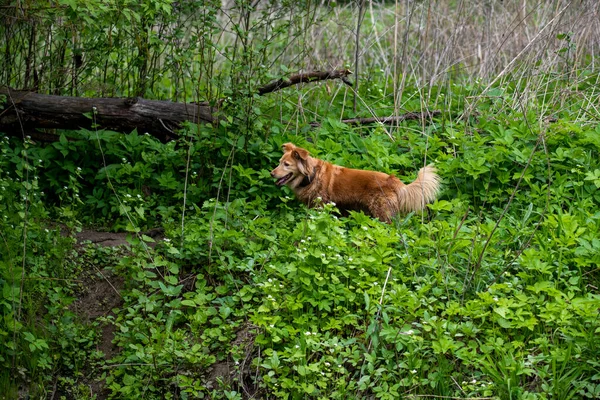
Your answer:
[398,165,440,213]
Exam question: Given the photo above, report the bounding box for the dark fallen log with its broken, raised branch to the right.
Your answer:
[0,69,351,142]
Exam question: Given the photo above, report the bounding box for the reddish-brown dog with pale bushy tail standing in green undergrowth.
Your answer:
[271,143,440,223]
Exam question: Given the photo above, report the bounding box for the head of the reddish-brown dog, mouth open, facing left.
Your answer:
[271,143,311,189]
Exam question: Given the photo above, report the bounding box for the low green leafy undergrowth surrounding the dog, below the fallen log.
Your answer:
[0,79,600,399]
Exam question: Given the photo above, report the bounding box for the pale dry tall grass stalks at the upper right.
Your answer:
[310,0,600,79]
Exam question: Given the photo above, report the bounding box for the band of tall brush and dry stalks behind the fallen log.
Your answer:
[0,0,600,100]
